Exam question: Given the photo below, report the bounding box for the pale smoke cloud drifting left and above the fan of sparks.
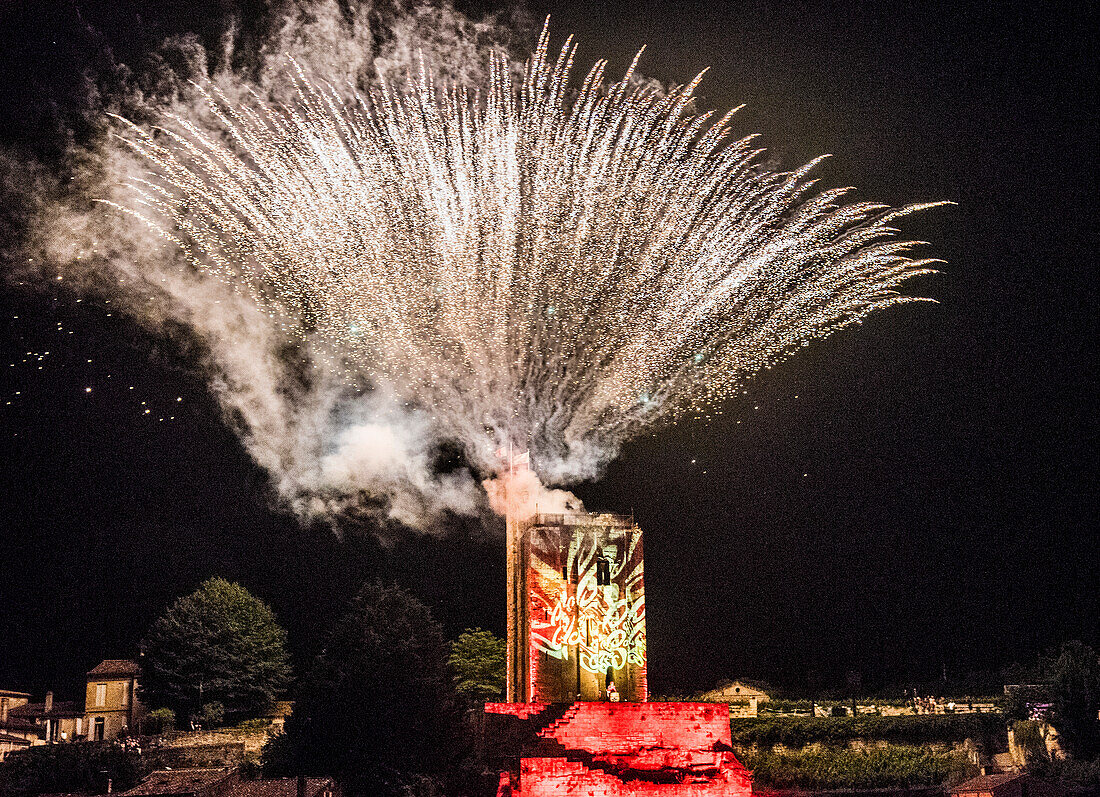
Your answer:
[4,0,545,530]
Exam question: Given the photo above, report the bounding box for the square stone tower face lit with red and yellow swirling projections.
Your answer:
[517,514,648,702]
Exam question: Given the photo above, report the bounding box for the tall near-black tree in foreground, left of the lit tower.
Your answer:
[283,584,454,795]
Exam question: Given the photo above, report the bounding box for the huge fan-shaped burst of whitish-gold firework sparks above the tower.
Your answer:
[105,30,946,480]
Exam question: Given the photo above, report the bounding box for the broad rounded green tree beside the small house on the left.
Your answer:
[141,578,290,720]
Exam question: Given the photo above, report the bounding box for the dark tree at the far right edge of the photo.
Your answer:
[1051,641,1100,759]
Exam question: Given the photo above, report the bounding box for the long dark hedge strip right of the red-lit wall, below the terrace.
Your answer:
[729,713,1005,748]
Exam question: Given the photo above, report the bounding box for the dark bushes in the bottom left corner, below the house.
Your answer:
[0,742,149,795]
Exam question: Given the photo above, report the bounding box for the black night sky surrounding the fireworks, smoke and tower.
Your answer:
[0,0,1100,694]
